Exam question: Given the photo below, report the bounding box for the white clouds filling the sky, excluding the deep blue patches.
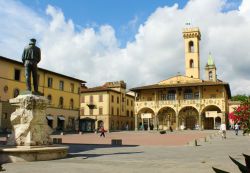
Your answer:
[0,0,250,94]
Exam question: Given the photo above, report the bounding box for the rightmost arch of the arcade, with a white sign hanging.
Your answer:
[201,105,222,129]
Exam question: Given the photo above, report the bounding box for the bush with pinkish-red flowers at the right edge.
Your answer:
[229,100,250,133]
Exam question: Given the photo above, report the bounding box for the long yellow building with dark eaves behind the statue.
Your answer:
[0,56,86,130]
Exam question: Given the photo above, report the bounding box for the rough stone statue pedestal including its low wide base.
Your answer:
[0,93,69,163]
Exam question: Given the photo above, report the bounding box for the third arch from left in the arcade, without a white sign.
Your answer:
[178,106,199,130]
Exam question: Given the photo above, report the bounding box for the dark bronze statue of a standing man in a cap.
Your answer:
[22,38,41,93]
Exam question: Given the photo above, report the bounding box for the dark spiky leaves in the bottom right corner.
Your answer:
[212,154,250,173]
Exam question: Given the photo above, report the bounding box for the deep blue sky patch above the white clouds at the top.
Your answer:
[17,0,242,47]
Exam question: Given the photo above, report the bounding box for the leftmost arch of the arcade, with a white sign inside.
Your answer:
[138,108,155,130]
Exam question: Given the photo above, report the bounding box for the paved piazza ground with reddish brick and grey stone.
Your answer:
[3,131,250,173]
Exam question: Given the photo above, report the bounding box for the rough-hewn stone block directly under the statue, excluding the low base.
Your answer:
[7,94,52,146]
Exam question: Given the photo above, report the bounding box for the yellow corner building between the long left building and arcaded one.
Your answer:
[80,81,134,132]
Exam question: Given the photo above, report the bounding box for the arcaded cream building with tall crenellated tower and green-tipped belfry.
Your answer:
[131,28,231,130]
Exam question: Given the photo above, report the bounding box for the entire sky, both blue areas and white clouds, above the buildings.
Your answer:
[0,0,250,95]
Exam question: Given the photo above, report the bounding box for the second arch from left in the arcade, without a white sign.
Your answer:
[157,107,176,130]
